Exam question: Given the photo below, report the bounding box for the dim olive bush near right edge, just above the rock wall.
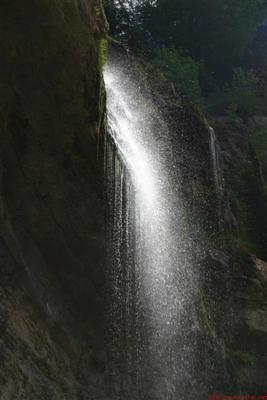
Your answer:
[225,68,261,117]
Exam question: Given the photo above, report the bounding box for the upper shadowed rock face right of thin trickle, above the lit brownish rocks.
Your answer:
[213,117,267,258]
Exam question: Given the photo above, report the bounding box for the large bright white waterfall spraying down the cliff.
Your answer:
[104,55,199,400]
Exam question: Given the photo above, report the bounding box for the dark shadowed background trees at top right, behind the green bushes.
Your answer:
[144,0,267,79]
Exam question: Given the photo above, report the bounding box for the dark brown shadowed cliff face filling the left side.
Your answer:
[0,0,109,400]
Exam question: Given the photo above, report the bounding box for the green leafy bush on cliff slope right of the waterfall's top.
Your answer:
[154,47,202,103]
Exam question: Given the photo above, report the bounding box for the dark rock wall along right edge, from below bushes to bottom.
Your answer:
[213,117,267,395]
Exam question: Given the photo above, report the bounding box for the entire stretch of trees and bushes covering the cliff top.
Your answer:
[106,0,267,117]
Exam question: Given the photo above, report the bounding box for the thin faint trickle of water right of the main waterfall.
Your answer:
[209,126,224,215]
